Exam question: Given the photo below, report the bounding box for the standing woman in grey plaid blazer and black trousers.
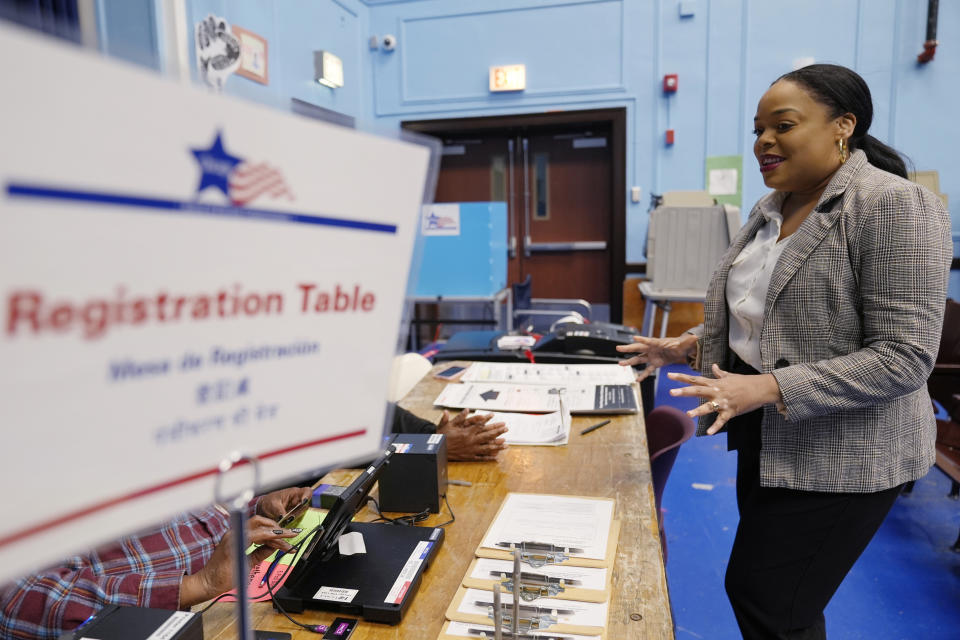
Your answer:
[618,64,952,639]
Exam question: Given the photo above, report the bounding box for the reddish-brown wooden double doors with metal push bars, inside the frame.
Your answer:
[430,121,620,311]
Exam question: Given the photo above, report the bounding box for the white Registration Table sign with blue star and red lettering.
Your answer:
[0,26,430,583]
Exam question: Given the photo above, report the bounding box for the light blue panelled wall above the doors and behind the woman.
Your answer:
[95,0,960,290]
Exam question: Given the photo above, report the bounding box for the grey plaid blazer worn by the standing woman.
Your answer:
[697,150,953,493]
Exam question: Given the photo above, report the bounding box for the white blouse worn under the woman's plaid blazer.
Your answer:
[727,194,792,372]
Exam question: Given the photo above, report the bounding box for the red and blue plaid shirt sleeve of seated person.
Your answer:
[0,508,229,639]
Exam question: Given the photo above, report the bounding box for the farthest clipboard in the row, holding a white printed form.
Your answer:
[477,493,620,568]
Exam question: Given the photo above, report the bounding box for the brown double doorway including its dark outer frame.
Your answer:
[402,108,627,322]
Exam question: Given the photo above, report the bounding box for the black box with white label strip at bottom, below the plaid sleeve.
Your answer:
[60,605,203,640]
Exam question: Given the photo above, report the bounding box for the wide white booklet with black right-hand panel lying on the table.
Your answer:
[433,382,639,413]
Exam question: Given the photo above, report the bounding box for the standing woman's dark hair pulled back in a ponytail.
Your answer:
[774,64,907,178]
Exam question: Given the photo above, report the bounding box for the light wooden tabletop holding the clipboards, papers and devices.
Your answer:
[204,362,674,640]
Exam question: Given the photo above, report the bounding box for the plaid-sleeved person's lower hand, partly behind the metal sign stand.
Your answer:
[180,516,297,608]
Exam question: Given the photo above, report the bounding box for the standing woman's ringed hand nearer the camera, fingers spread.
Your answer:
[667,364,782,435]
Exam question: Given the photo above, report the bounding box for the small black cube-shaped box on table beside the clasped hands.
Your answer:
[380,433,447,513]
